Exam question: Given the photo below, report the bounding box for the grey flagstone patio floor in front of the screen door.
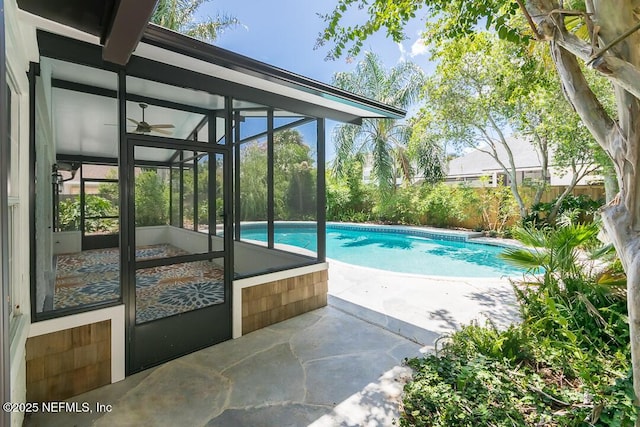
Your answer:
[25,306,428,427]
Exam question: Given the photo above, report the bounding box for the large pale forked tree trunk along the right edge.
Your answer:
[527,0,640,410]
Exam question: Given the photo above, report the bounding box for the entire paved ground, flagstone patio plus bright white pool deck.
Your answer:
[25,261,517,427]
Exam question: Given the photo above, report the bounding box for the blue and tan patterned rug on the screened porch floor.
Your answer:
[54,244,224,323]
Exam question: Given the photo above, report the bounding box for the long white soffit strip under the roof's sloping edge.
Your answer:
[134,43,385,118]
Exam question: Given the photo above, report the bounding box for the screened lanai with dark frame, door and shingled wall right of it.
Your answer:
[22,22,403,382]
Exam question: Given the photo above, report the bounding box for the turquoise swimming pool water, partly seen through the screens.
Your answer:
[241,223,522,277]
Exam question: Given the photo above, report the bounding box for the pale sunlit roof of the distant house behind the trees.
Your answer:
[447,138,541,177]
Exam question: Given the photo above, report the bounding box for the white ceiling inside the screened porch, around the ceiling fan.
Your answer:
[41,57,322,161]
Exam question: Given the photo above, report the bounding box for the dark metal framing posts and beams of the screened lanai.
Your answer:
[26,26,340,373]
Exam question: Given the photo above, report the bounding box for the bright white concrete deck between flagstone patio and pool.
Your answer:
[329,260,519,346]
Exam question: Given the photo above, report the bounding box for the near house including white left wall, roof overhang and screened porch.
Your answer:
[0,0,405,425]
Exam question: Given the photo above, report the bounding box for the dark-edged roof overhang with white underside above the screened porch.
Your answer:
[18,0,406,124]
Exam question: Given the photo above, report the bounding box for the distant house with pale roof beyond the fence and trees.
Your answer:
[445,138,602,187]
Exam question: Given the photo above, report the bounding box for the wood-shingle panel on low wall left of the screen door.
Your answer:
[26,320,111,402]
